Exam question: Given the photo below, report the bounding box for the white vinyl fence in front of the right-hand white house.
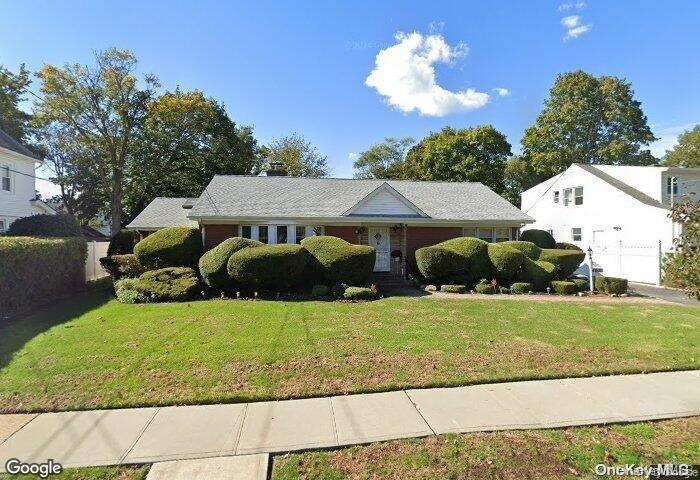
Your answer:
[586,241,663,285]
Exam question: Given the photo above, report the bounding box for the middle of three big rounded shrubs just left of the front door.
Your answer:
[227,243,308,291]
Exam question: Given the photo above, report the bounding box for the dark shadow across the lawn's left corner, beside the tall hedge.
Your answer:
[0,284,114,369]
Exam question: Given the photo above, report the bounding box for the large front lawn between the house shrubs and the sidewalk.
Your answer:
[0,291,700,412]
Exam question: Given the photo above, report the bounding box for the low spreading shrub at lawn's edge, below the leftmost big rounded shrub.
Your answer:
[134,267,201,302]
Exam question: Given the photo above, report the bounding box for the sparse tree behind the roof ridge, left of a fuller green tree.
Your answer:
[353,137,415,179]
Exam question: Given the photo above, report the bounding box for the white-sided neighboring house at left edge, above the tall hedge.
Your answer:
[0,130,39,232]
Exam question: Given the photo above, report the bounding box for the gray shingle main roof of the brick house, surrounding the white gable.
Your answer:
[189,175,533,223]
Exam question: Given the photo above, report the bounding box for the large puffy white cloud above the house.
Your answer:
[365,32,489,117]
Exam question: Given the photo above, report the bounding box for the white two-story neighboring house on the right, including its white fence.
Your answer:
[521,164,700,283]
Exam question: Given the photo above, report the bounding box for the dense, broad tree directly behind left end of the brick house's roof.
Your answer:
[125,89,261,218]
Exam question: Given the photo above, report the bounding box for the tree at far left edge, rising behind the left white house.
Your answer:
[0,64,31,144]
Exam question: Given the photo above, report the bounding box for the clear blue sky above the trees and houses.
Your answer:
[0,0,700,197]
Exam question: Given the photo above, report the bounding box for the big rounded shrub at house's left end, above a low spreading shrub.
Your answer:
[134,227,202,270]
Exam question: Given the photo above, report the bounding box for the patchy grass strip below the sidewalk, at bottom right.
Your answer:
[272,417,700,480]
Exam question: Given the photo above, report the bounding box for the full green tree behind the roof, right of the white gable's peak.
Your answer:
[406,125,511,193]
